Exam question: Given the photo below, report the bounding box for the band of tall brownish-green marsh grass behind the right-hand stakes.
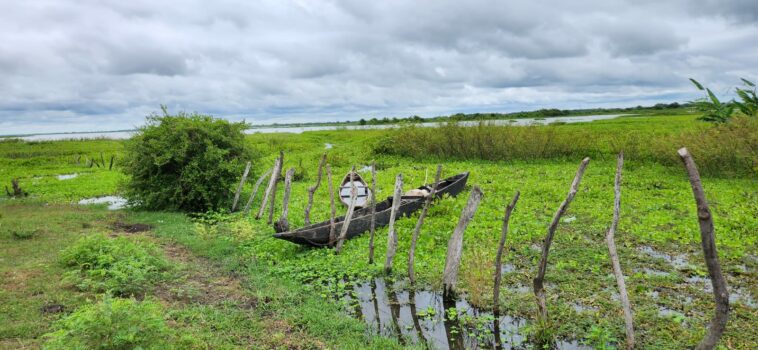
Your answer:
[374,116,758,176]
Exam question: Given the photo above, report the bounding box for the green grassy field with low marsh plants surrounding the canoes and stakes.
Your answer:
[0,115,758,349]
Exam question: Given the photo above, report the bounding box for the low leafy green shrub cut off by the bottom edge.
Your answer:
[44,297,173,350]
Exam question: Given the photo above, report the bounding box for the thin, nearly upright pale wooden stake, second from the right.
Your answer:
[605,152,634,350]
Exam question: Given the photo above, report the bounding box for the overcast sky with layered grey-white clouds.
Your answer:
[0,0,758,134]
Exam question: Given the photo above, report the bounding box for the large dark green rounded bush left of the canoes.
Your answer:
[123,108,251,212]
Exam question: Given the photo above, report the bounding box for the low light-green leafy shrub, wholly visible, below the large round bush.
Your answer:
[60,235,168,295]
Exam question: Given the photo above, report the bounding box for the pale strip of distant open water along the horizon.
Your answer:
[13,114,623,142]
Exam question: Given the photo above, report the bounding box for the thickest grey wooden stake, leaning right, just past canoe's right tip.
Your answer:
[442,186,484,297]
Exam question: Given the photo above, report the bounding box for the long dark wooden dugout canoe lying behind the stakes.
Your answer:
[274,172,468,247]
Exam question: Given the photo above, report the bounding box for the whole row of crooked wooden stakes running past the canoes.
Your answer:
[232,148,729,350]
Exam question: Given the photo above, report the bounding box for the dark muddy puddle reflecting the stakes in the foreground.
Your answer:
[347,278,588,349]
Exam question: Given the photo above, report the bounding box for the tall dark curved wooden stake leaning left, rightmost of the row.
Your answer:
[678,148,729,350]
